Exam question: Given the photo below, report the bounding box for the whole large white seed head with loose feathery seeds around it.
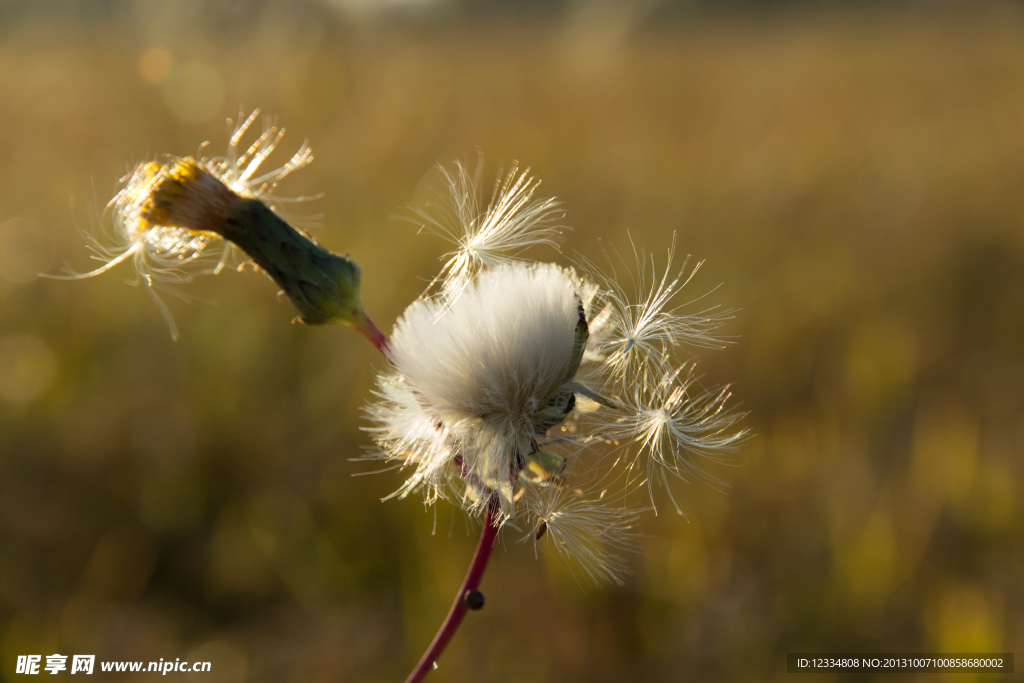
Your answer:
[368,158,745,581]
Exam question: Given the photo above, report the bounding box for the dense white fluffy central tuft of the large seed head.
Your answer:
[374,264,584,514]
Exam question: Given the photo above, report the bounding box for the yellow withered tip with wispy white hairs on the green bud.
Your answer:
[44,110,313,338]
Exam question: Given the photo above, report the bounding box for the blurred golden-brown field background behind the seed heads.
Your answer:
[0,0,1024,683]
